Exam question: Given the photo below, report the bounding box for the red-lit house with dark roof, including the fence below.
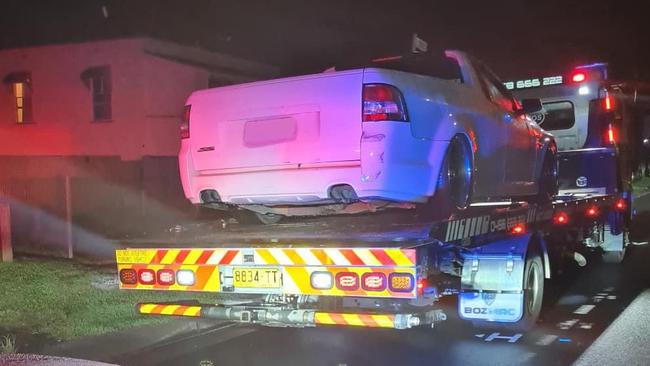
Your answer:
[0,37,278,254]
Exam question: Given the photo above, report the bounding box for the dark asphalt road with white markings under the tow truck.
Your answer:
[119,195,650,366]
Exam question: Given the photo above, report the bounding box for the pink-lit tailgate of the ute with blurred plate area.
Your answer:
[188,70,362,171]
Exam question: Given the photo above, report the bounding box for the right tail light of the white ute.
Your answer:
[362,84,408,122]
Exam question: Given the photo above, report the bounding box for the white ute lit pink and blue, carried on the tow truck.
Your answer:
[179,51,556,223]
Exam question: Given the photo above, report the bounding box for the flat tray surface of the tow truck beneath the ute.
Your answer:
[120,194,611,248]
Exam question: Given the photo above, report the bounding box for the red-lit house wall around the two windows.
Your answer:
[0,39,209,160]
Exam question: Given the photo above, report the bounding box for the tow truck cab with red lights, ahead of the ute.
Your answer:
[504,63,631,199]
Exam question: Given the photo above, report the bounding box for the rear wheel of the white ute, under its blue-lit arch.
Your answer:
[420,136,474,220]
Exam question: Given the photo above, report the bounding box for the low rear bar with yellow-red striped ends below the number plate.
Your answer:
[136,303,447,329]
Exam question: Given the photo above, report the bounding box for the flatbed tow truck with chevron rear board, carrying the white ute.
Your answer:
[116,62,632,331]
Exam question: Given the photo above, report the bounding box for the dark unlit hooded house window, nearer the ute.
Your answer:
[81,66,112,122]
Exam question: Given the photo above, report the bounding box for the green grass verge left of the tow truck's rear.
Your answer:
[0,258,216,341]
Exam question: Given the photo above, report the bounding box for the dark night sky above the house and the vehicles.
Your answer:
[0,0,650,80]
